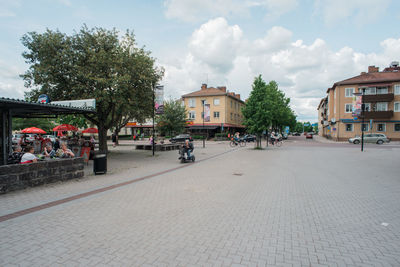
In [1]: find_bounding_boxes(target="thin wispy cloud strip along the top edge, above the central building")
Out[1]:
[164,0,298,22]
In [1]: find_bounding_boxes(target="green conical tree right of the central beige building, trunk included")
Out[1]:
[242,75,296,147]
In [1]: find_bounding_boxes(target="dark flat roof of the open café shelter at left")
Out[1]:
[0,97,96,118]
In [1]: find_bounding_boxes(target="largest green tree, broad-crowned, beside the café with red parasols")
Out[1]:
[21,26,163,154]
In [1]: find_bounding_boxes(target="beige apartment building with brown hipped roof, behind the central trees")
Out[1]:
[182,84,245,136]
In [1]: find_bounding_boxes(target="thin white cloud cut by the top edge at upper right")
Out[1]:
[315,0,391,26]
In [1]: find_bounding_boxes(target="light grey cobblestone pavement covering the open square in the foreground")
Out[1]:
[0,140,400,266]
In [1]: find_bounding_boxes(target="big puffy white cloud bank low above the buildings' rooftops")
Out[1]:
[161,18,400,121]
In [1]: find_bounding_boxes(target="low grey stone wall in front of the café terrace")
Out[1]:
[0,158,84,193]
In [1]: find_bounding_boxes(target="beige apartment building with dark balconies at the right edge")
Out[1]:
[318,62,400,141]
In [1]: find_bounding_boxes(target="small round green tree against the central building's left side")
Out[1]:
[156,100,187,135]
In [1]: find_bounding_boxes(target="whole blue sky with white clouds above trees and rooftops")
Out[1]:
[0,0,400,122]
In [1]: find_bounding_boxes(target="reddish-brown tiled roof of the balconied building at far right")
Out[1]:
[335,71,400,86]
